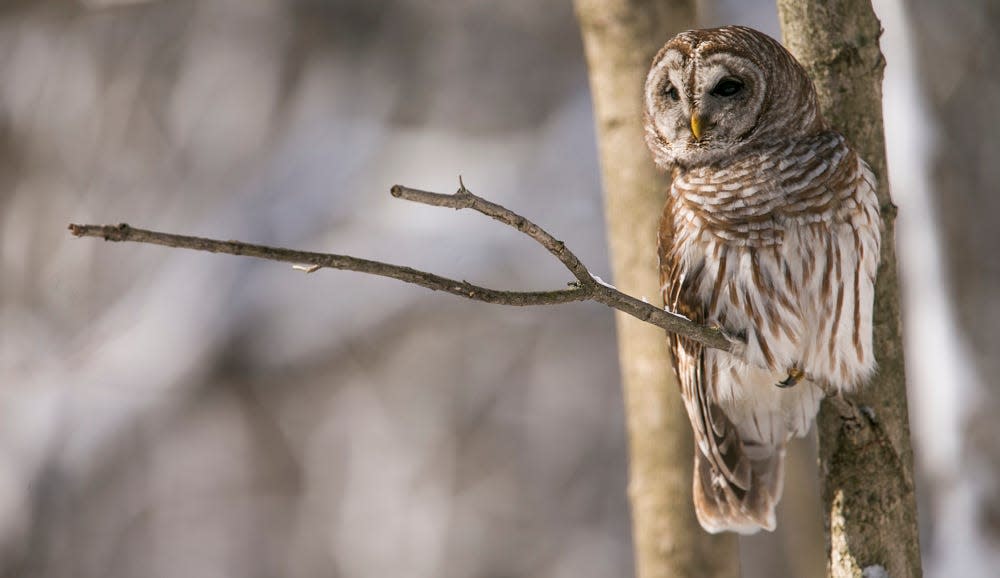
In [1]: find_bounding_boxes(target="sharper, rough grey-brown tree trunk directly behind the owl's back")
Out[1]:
[778,0,921,578]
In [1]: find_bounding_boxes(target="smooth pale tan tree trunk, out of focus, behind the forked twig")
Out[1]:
[575,0,739,578]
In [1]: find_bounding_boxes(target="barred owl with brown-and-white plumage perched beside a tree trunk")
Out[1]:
[645,26,880,534]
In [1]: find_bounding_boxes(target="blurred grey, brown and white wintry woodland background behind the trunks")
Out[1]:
[0,0,1000,577]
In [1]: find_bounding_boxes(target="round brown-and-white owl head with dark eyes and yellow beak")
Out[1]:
[645,26,823,168]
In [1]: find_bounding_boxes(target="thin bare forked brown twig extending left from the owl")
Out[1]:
[69,184,735,351]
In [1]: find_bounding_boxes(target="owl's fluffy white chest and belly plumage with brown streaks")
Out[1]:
[664,132,879,400]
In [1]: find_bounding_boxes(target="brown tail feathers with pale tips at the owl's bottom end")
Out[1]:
[694,434,785,534]
